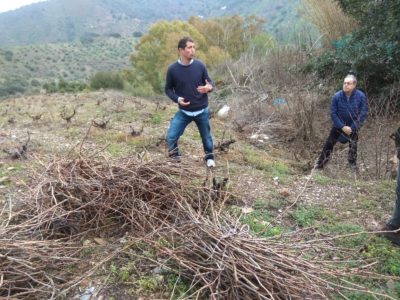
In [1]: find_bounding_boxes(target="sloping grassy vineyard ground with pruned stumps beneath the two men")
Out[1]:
[0,91,400,299]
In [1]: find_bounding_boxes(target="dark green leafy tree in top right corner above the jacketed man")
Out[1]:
[306,0,400,102]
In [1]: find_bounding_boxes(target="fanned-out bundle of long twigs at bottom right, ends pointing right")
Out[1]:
[138,218,390,300]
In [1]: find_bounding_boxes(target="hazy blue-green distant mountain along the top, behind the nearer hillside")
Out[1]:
[0,0,299,47]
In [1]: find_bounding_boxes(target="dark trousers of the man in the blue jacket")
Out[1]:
[317,127,358,167]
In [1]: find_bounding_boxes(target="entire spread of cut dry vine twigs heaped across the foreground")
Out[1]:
[0,156,396,299]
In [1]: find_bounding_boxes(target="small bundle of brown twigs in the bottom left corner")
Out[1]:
[0,239,79,299]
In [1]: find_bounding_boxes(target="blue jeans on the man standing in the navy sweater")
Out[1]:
[167,108,214,160]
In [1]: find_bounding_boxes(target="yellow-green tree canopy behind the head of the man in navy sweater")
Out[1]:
[131,16,265,92]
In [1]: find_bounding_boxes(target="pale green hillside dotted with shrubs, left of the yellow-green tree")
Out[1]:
[0,36,135,97]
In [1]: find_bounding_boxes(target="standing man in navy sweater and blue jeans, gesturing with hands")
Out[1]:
[165,37,215,167]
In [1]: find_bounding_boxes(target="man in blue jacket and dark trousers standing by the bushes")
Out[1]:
[315,75,368,170]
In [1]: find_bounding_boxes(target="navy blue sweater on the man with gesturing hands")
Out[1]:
[165,60,212,111]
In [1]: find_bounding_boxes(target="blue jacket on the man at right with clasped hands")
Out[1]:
[330,89,368,131]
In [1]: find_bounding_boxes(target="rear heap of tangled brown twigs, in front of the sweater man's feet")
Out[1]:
[12,157,210,238]
